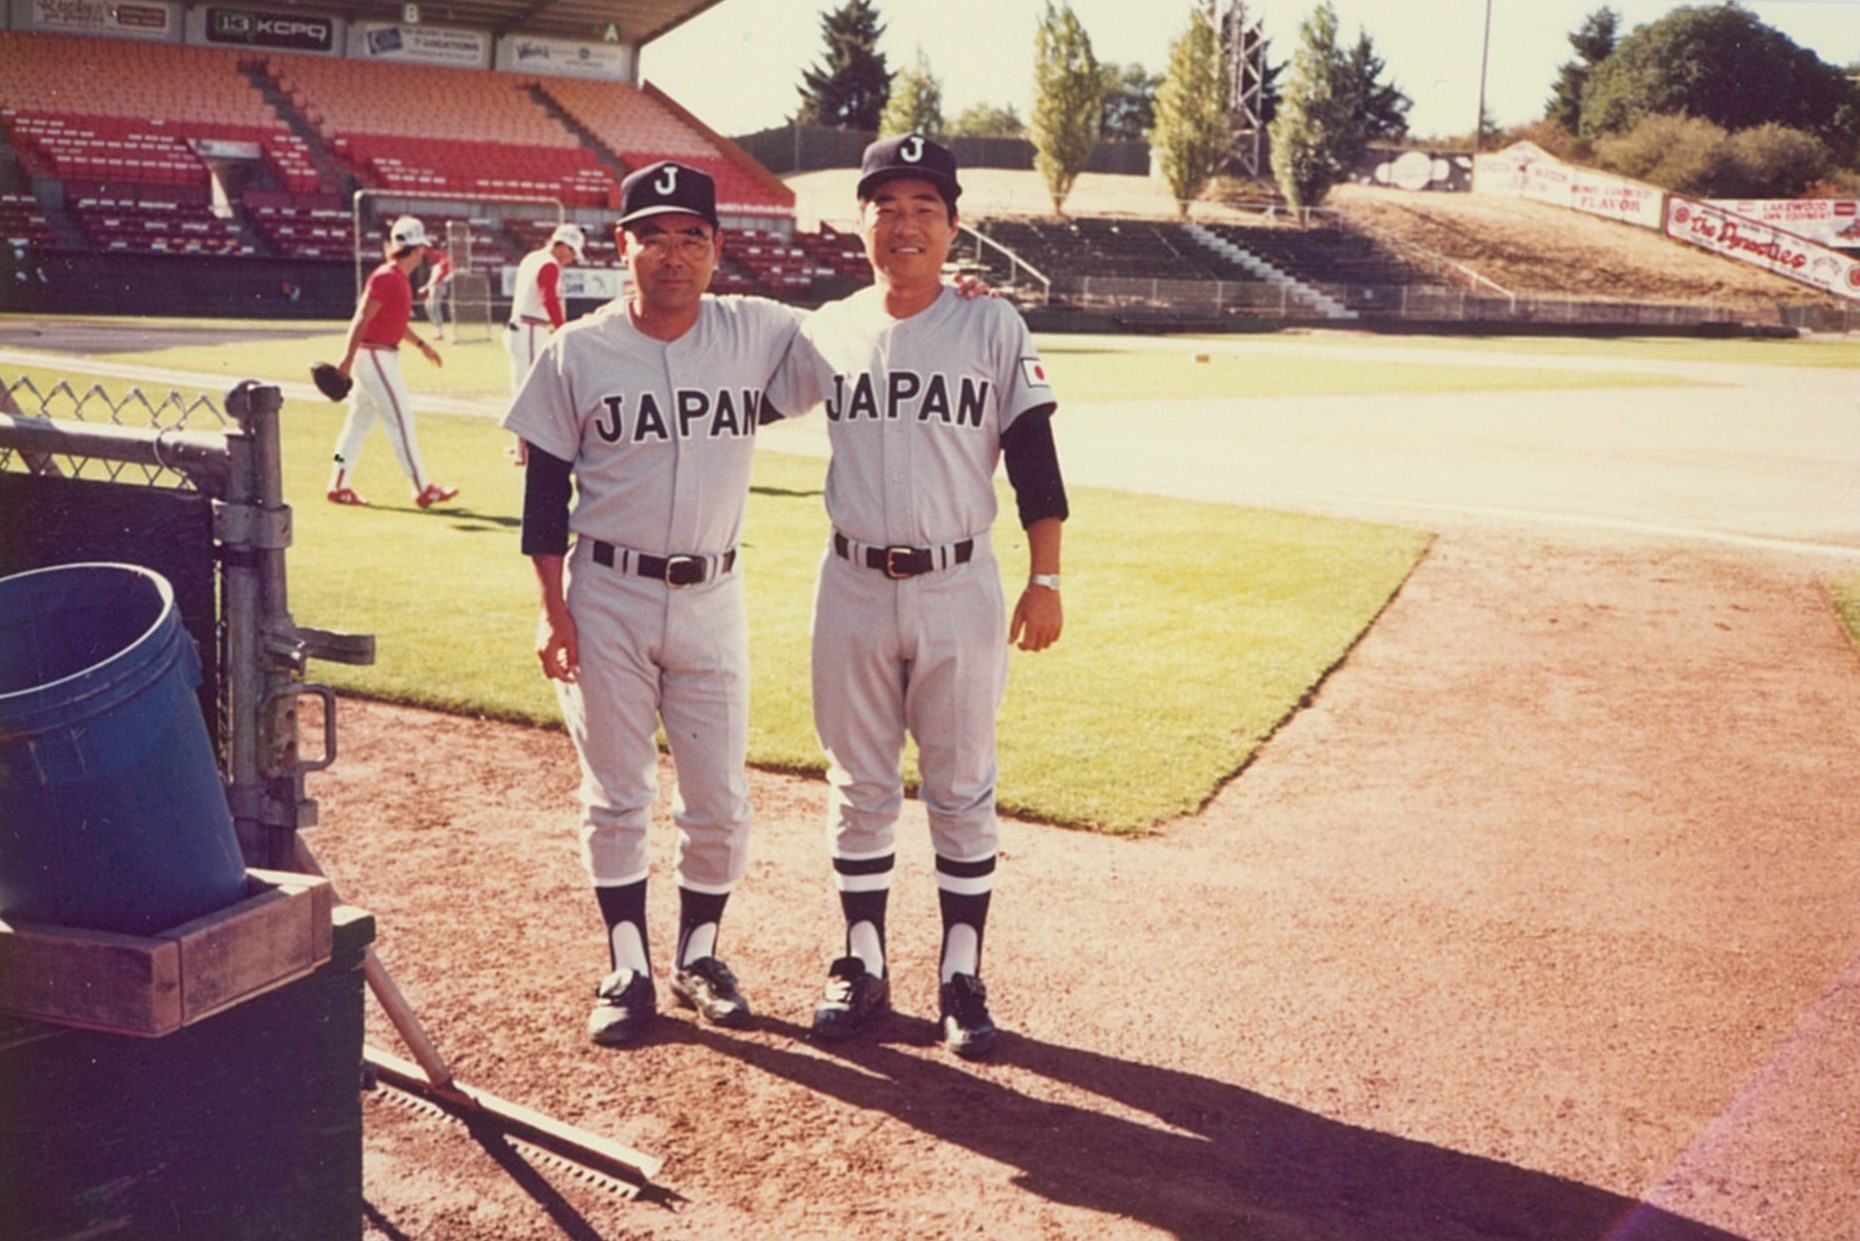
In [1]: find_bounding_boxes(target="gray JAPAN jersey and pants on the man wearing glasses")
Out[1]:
[504,296,796,893]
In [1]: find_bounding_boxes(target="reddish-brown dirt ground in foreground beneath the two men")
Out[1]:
[309,530,1860,1241]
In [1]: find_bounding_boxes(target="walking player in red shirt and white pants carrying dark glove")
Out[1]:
[327,216,459,508]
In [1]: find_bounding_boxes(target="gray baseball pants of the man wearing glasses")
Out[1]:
[556,540,751,893]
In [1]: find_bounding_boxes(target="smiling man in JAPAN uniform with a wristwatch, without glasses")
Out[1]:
[770,134,1068,1059]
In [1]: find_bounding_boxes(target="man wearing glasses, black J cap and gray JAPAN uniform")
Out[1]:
[504,162,798,1046]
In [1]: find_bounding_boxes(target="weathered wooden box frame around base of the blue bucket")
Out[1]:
[0,871,333,1038]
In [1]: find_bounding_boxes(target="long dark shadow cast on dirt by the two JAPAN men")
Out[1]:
[688,1018,1739,1241]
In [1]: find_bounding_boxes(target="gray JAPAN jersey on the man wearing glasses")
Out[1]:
[504,296,798,556]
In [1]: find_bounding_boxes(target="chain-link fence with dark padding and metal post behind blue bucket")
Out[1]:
[0,376,374,871]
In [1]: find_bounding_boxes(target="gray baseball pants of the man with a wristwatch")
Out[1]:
[813,536,1008,861]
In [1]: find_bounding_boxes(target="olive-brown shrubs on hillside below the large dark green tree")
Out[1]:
[1596,115,1834,199]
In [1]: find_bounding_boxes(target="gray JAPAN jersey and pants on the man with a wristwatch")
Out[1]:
[770,287,1055,870]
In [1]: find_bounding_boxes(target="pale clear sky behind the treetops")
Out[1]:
[642,0,1860,136]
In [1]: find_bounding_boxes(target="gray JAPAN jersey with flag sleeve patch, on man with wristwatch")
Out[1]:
[770,287,1055,547]
